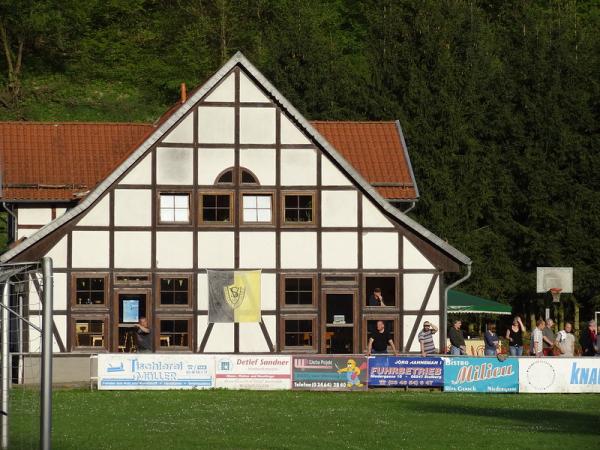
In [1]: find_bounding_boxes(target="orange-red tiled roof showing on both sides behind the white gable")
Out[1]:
[0,121,418,201]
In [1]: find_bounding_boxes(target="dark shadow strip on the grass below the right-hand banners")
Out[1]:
[403,401,600,435]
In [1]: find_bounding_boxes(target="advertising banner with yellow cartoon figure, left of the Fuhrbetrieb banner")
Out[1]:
[292,355,368,391]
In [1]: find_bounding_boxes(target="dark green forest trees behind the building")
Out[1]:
[0,0,600,317]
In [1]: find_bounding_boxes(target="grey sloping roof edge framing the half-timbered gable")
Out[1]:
[0,52,471,265]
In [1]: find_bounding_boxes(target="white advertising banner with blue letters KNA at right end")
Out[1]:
[519,357,600,393]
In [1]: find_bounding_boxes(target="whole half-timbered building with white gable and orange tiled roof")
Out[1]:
[0,53,471,353]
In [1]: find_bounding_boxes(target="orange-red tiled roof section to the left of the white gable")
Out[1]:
[0,122,154,201]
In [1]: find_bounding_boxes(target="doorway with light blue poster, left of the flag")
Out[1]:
[113,289,152,353]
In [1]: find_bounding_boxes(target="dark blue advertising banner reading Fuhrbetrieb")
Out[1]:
[369,356,444,387]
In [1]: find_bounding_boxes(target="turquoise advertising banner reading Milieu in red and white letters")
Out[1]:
[444,357,519,393]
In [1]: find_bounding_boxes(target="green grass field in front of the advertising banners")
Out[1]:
[10,389,600,450]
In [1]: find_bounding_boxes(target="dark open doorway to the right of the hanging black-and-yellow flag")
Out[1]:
[321,289,358,354]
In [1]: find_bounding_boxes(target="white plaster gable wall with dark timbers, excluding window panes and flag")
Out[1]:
[2,53,466,353]
